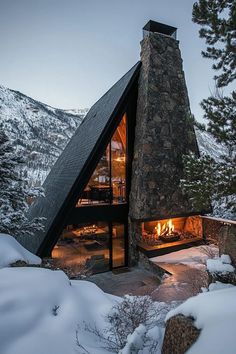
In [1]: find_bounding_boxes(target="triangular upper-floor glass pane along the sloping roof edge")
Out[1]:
[78,145,112,206]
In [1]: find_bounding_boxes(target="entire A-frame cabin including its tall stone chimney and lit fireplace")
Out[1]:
[22,21,208,272]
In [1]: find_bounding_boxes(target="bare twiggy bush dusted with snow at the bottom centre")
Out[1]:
[82,295,161,354]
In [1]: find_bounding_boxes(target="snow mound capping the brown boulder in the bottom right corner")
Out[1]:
[166,287,236,354]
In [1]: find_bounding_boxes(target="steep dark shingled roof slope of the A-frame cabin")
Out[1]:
[25,62,141,252]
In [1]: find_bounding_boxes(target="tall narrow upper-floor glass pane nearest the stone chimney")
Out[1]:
[111,114,127,204]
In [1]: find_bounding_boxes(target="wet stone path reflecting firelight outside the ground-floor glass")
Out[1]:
[88,263,205,302]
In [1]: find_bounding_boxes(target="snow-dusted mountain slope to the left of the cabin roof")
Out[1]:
[0,86,87,185]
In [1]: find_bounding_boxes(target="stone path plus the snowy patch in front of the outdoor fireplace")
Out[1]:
[88,245,218,302]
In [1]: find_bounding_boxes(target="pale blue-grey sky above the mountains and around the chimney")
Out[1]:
[0,0,217,119]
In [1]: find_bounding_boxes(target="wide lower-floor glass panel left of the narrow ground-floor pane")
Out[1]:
[52,222,110,273]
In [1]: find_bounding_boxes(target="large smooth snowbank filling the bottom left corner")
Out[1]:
[0,267,114,354]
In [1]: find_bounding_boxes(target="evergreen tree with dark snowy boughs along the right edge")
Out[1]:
[181,0,236,217]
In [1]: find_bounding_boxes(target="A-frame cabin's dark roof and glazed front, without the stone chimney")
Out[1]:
[28,63,141,271]
